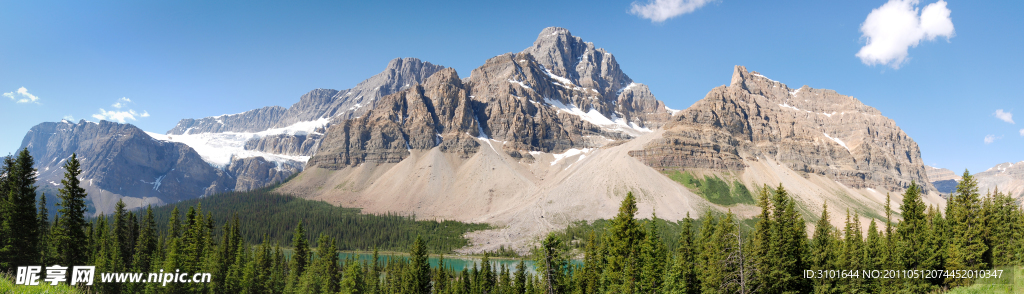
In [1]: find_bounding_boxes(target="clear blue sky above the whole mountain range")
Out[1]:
[0,0,1024,172]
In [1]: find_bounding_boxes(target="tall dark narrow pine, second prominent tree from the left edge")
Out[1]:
[51,154,89,265]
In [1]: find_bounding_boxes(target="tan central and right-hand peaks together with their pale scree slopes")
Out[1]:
[280,28,944,254]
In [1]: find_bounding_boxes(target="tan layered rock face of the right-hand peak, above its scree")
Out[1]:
[631,66,934,192]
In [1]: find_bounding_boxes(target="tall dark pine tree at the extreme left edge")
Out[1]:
[0,149,40,270]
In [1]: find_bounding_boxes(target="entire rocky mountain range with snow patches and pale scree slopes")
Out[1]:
[16,28,1024,251]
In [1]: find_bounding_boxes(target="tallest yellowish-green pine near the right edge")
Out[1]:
[946,171,988,287]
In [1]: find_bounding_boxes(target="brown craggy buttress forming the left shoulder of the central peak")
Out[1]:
[307,69,479,168]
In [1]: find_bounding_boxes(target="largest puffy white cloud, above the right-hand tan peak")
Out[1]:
[857,0,955,69]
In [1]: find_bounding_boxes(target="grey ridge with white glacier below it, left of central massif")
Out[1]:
[152,58,444,176]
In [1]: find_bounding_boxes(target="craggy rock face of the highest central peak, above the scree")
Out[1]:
[307,28,671,169]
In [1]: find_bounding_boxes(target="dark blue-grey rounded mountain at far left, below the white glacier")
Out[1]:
[22,121,298,212]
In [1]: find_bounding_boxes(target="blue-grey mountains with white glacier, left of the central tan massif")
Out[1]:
[22,58,443,212]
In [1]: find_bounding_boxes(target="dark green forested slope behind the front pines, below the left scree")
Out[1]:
[153,187,489,252]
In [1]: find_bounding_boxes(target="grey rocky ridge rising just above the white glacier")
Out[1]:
[167,58,444,135]
